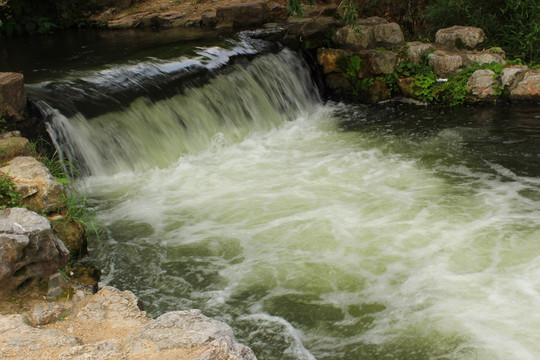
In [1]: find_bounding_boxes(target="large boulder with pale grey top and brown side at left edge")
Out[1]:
[0,208,69,293]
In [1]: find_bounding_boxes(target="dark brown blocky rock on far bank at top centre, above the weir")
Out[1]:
[216,2,268,28]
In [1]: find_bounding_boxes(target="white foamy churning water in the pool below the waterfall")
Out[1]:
[82,103,540,359]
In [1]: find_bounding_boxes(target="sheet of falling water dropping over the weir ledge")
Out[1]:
[43,50,318,174]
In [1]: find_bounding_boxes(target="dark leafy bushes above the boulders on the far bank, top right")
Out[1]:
[288,0,540,64]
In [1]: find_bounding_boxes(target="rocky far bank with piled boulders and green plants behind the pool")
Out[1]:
[93,1,540,105]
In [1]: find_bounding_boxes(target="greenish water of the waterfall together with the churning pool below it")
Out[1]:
[4,28,540,360]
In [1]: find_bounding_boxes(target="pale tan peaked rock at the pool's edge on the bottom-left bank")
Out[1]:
[77,286,149,326]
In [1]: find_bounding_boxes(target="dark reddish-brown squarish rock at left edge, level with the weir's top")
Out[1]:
[0,72,26,120]
